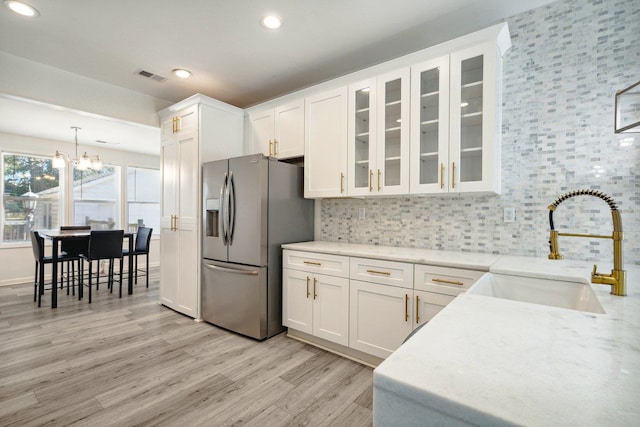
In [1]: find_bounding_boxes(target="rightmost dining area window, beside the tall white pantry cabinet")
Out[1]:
[127,167,161,235]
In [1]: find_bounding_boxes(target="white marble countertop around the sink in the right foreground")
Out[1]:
[374,256,640,426]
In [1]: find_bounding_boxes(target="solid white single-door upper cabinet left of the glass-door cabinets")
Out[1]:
[304,87,347,198]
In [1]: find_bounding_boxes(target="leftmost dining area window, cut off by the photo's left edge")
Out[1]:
[2,153,62,243]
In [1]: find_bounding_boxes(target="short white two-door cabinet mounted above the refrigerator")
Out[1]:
[248,99,304,159]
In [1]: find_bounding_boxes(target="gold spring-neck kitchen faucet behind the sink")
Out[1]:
[549,190,627,296]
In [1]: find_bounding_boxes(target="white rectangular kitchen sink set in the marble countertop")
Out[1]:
[467,273,605,313]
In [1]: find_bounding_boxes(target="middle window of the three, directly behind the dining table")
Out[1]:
[73,165,120,230]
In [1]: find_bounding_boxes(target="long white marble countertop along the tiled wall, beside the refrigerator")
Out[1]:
[282,241,500,271]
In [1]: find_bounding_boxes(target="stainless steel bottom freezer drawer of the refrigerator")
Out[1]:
[202,260,267,339]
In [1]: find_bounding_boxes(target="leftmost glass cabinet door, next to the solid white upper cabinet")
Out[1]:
[347,79,376,196]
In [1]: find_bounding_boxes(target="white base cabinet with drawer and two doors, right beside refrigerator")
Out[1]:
[282,251,349,346]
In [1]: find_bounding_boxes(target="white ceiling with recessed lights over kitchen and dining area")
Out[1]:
[0,0,553,152]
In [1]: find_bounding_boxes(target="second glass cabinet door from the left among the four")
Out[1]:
[374,68,410,194]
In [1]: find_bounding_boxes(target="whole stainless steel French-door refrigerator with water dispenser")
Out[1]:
[201,154,314,340]
